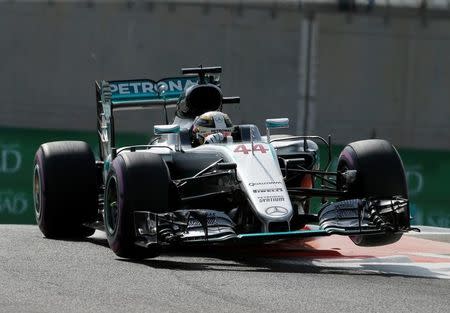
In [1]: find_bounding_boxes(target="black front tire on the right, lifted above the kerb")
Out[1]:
[337,139,410,247]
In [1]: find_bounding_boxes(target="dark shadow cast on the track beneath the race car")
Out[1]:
[86,229,442,279]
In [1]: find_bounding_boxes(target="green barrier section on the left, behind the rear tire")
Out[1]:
[0,128,149,224]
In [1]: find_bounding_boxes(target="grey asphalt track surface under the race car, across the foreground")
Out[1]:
[0,225,450,313]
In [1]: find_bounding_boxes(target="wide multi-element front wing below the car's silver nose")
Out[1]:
[134,197,410,247]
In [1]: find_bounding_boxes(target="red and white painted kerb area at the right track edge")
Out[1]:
[268,226,450,280]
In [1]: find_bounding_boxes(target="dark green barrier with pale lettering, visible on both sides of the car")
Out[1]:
[0,128,450,227]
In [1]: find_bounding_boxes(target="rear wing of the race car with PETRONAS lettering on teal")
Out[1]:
[95,66,240,160]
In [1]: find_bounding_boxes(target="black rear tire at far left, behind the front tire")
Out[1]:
[33,141,98,239]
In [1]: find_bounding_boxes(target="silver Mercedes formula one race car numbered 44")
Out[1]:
[34,67,411,258]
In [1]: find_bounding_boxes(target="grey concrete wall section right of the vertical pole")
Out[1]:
[314,15,450,149]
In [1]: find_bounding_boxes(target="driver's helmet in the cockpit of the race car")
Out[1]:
[192,111,233,146]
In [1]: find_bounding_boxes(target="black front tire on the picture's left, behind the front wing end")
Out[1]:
[104,152,172,259]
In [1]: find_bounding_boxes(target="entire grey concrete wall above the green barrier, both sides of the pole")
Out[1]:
[0,1,450,149]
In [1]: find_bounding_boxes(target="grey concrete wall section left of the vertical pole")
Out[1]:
[0,1,301,132]
